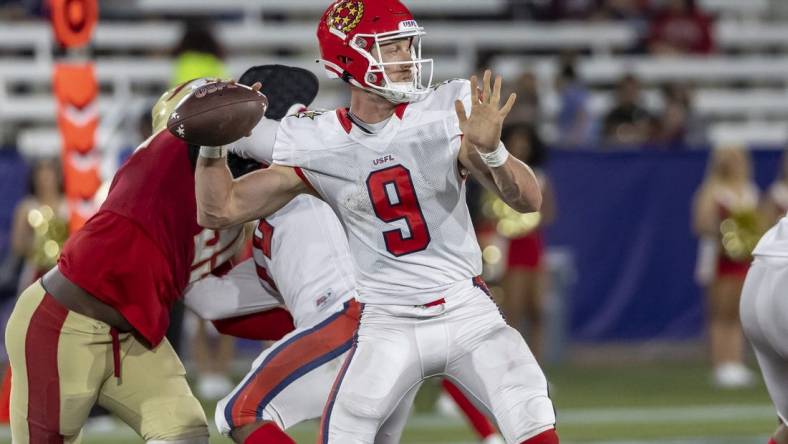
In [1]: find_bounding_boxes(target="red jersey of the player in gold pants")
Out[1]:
[58,131,243,346]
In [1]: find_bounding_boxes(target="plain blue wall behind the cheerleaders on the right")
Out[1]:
[548,150,780,342]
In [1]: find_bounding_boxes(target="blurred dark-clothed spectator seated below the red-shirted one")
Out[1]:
[655,83,706,149]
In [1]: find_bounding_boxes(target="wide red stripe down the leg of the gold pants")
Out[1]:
[25,294,68,444]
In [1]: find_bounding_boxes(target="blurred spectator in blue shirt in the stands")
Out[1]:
[555,59,594,148]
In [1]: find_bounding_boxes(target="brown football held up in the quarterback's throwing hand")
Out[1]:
[167,81,268,146]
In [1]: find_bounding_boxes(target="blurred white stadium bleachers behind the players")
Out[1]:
[0,0,788,158]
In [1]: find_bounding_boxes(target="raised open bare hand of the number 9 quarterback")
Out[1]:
[454,69,517,152]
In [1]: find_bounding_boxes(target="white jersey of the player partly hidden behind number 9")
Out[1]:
[252,194,356,327]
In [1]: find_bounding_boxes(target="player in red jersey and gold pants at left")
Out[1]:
[5,80,290,444]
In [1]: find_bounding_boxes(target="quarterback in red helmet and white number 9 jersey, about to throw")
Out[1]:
[197,0,558,444]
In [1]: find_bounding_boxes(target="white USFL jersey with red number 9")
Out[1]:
[274,80,481,305]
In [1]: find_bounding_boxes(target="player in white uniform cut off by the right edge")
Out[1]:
[739,212,788,444]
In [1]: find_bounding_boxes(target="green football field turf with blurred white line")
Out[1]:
[0,363,776,444]
